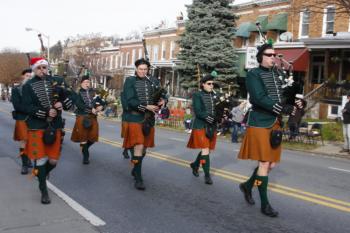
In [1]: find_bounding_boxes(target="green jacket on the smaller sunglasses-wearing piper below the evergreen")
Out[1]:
[192,90,216,129]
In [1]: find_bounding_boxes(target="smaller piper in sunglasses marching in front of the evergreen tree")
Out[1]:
[187,74,218,185]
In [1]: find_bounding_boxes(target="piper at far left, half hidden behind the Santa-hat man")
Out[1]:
[11,69,32,175]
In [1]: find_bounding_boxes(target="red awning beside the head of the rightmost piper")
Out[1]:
[275,48,310,72]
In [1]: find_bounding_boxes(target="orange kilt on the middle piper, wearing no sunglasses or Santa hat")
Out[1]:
[123,122,154,148]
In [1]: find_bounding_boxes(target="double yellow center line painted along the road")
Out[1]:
[0,109,350,213]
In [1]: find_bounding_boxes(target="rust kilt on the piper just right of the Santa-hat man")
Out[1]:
[71,114,98,142]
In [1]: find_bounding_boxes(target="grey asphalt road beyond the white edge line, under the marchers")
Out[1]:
[0,103,350,233]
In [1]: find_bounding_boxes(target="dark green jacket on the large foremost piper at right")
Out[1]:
[246,67,281,128]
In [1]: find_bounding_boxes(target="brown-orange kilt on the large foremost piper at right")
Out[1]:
[238,123,282,162]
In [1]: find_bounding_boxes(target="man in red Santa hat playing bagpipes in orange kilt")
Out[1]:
[22,57,72,204]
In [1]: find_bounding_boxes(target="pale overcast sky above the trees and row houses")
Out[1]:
[0,0,247,52]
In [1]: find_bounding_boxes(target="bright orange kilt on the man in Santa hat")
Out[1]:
[26,129,62,160]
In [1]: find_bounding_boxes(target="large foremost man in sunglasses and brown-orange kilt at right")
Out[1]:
[238,43,303,217]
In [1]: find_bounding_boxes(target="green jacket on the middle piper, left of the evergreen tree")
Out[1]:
[123,76,159,125]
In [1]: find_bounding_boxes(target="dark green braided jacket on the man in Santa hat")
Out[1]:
[22,76,72,130]
